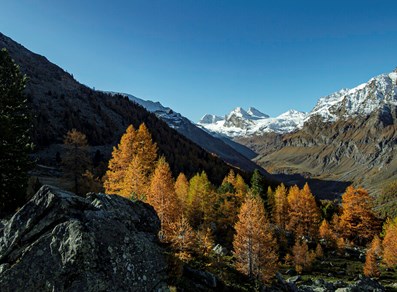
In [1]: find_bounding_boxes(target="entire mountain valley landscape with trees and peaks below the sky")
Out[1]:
[0,28,397,291]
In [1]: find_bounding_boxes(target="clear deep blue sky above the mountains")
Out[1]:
[0,0,397,121]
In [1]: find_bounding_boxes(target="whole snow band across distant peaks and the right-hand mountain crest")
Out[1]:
[198,71,397,137]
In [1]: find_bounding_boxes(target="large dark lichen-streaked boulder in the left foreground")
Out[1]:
[0,186,167,291]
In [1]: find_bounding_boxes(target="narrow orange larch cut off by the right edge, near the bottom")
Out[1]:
[382,217,397,268]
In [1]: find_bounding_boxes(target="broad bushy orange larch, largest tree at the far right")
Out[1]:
[340,186,380,244]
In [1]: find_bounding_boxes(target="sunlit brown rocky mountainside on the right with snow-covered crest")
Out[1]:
[236,72,397,193]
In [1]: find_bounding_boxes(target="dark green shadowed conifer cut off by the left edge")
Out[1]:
[0,49,33,217]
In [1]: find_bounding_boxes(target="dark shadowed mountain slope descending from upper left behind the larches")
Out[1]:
[0,33,268,183]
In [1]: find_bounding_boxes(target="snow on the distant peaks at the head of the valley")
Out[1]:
[198,107,307,137]
